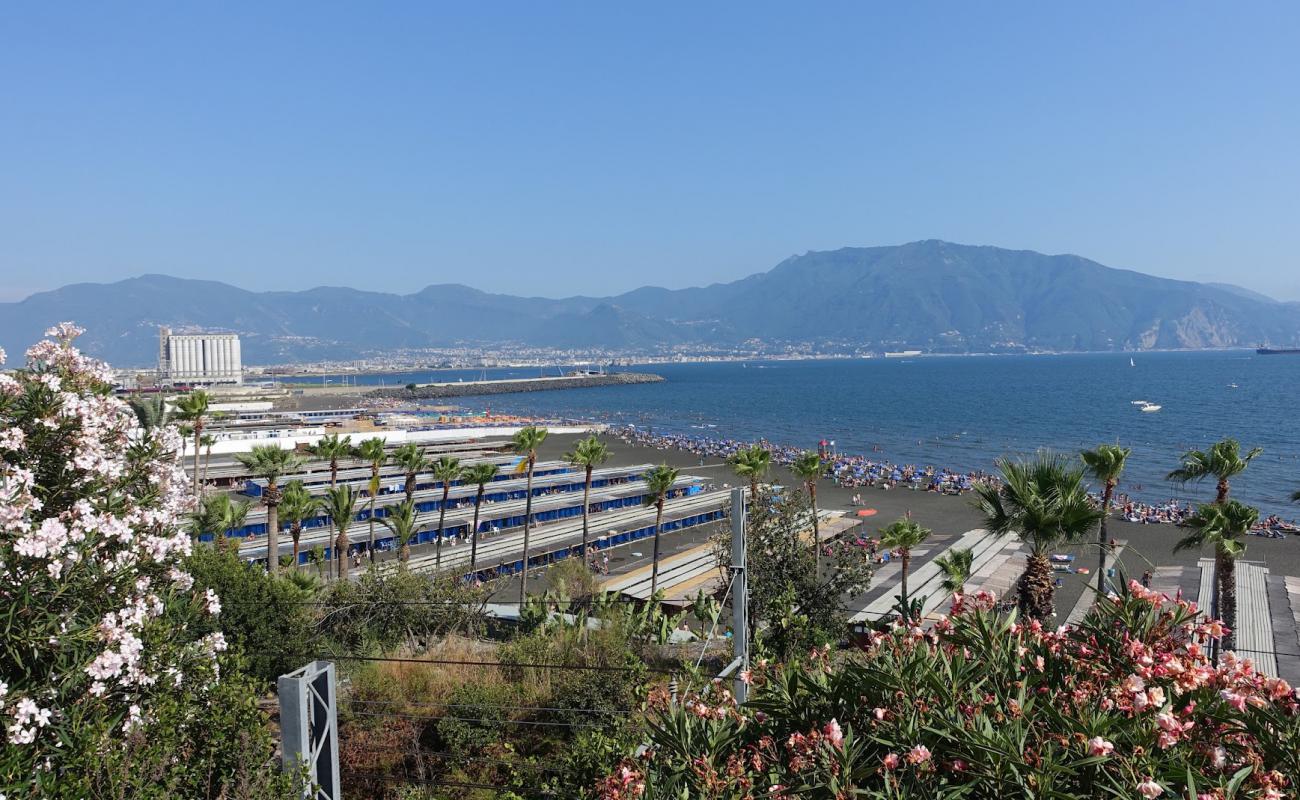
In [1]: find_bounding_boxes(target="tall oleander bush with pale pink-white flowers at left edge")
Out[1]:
[0,324,286,800]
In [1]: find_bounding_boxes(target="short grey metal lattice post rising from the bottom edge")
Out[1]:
[276,661,343,800]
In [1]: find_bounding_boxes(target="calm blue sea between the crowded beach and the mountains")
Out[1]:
[332,351,1300,518]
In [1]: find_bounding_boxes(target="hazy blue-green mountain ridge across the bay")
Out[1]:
[0,239,1300,366]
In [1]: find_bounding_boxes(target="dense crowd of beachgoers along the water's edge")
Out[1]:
[610,425,1300,537]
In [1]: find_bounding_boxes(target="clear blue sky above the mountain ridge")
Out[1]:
[0,1,1300,299]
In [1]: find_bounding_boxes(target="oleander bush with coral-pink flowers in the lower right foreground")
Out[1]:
[598,583,1300,800]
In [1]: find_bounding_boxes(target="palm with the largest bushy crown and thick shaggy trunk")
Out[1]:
[975,453,1101,619]
